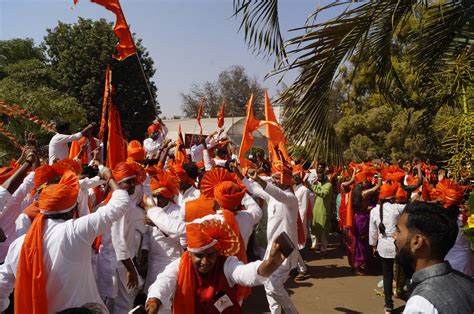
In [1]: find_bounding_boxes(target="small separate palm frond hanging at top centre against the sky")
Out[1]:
[234,0,287,62]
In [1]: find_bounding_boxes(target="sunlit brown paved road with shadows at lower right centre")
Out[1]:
[243,236,404,314]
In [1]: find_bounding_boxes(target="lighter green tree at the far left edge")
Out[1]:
[0,39,86,163]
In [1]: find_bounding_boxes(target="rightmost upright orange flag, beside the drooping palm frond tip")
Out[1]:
[265,91,290,162]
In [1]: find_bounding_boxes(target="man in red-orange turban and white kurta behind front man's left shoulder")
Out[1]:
[142,172,186,291]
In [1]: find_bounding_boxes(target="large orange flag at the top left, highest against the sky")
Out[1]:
[74,0,137,61]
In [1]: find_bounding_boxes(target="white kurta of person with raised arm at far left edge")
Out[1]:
[0,171,35,262]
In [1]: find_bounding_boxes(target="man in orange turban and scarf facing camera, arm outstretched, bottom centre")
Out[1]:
[146,215,284,314]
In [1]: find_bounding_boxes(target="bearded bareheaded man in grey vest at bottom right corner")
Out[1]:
[394,202,474,314]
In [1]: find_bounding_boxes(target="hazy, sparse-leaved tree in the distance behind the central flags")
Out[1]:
[181,65,264,118]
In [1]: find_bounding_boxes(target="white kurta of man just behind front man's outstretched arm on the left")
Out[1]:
[143,202,186,291]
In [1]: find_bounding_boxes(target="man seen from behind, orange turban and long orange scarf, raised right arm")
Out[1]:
[0,168,129,313]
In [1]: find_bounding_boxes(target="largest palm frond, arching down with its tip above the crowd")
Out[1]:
[273,0,422,161]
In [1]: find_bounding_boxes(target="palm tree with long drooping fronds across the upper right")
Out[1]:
[234,0,474,162]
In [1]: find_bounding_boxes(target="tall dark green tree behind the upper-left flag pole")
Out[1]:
[42,18,159,138]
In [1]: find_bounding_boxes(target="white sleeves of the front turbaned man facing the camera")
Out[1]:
[148,256,267,309]
